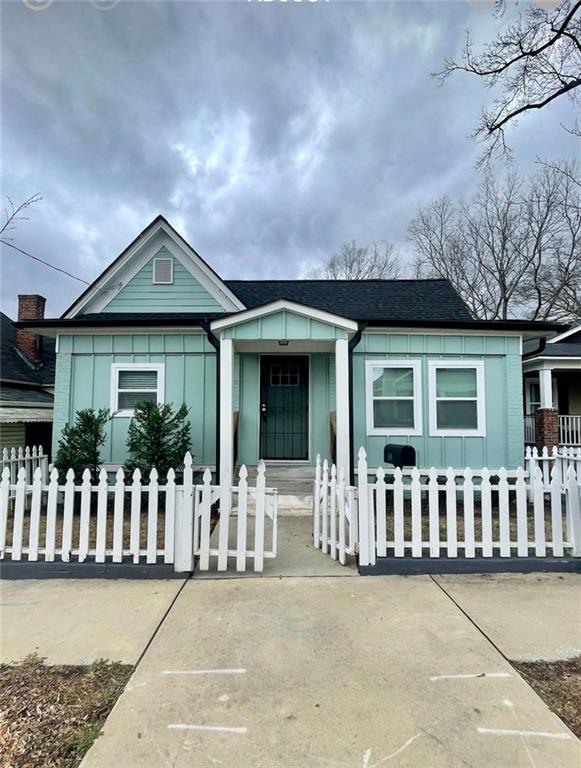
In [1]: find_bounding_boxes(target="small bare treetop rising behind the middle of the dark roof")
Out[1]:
[307,240,400,280]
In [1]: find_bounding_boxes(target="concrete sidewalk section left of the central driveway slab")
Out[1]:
[0,579,183,664]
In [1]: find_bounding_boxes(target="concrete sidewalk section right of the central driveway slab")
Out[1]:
[434,573,581,661]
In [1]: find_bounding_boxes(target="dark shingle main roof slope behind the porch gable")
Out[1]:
[225,280,472,322]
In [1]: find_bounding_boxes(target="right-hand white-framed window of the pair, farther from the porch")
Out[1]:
[428,360,486,437]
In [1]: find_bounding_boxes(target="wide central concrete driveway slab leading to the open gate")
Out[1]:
[83,576,581,768]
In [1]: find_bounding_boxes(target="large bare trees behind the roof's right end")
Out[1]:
[409,164,581,320]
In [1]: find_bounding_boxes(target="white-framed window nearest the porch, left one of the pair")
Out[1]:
[365,360,422,435]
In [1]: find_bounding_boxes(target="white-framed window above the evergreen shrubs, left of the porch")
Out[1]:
[111,363,165,417]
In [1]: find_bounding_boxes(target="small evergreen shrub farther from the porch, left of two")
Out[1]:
[54,408,111,482]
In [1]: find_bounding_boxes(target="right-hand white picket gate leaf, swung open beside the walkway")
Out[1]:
[313,455,358,565]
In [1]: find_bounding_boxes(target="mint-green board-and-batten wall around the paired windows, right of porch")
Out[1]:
[353,332,524,469]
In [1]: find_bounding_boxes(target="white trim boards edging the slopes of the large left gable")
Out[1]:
[64,221,245,320]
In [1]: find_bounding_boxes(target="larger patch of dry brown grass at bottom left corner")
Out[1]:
[0,656,133,768]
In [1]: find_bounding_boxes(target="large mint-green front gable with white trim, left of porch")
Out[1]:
[63,216,245,320]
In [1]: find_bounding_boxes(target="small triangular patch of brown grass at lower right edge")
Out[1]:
[511,656,581,738]
